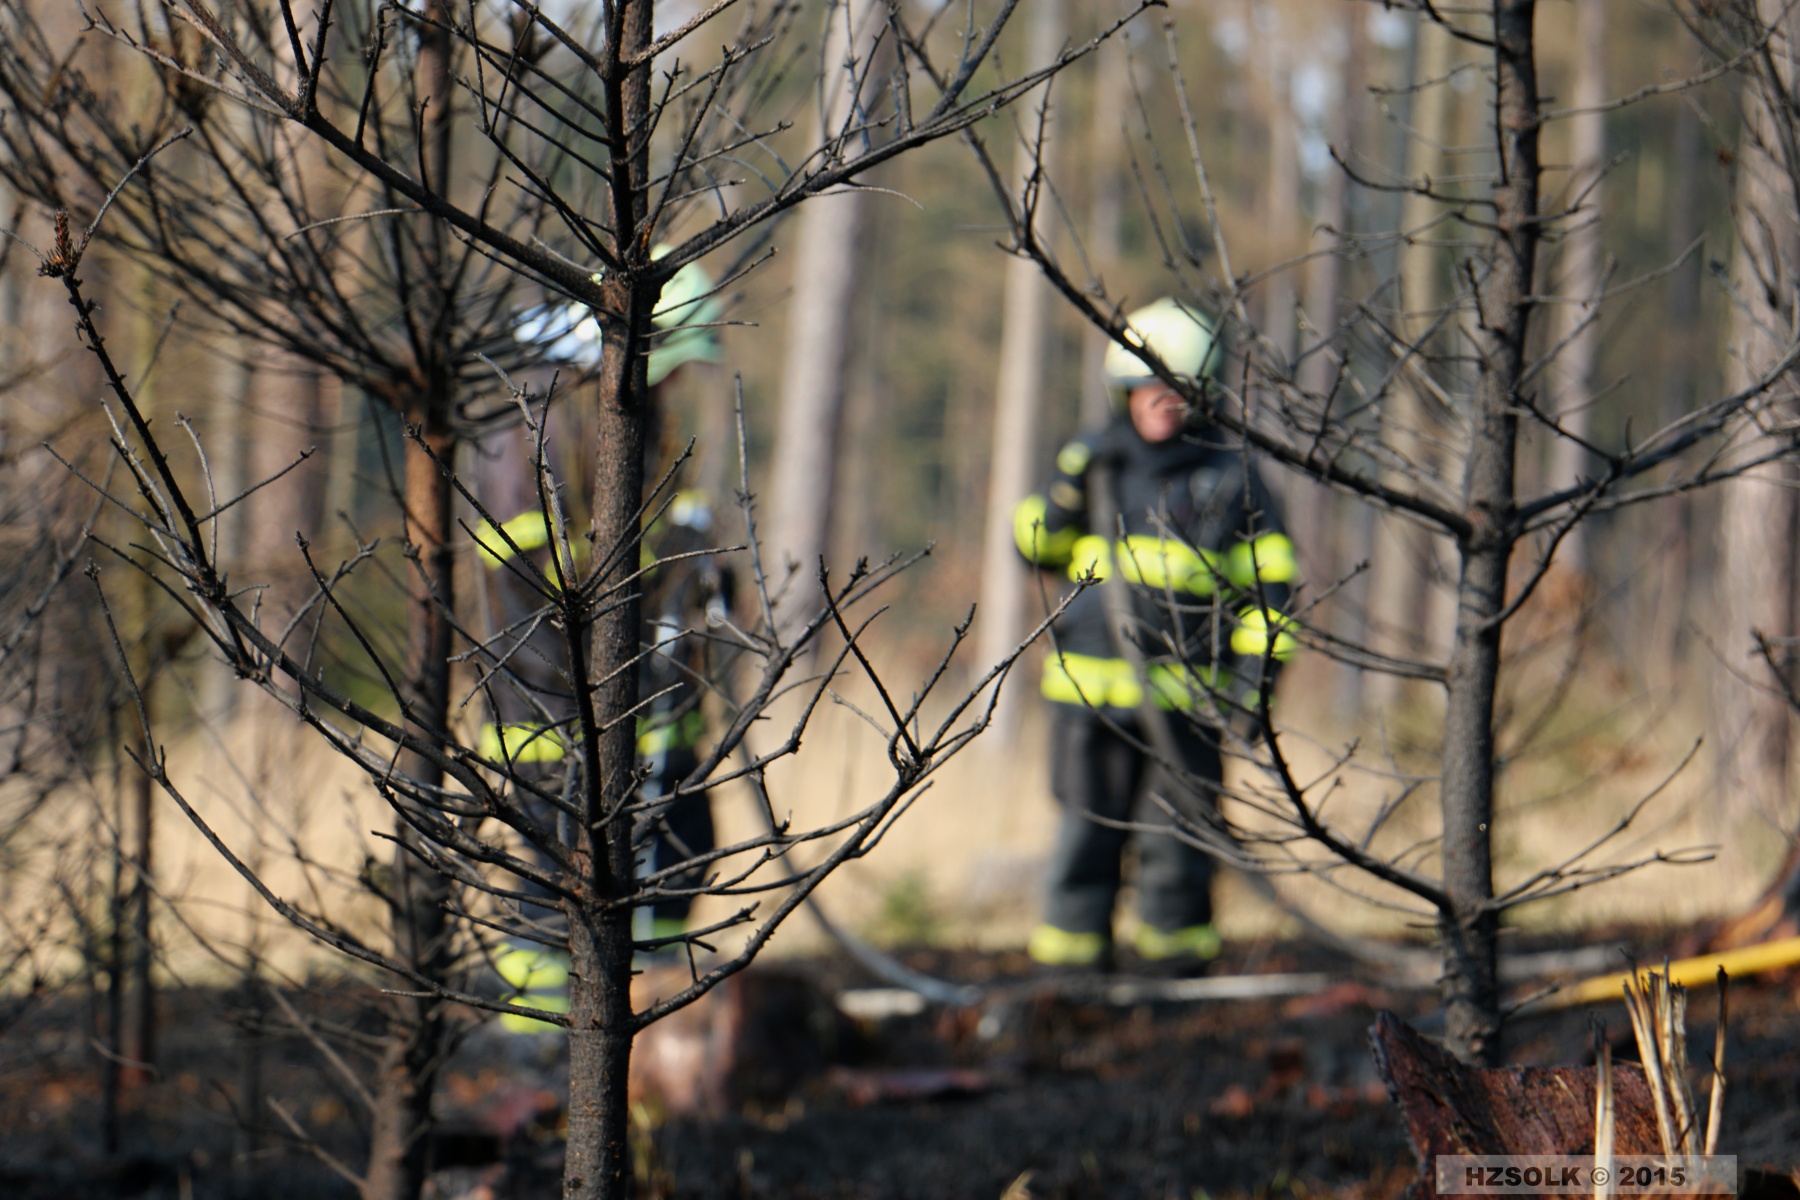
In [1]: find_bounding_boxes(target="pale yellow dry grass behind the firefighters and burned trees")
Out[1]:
[4,633,1782,979]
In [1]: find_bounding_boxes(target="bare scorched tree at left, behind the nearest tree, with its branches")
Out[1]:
[0,4,604,1200]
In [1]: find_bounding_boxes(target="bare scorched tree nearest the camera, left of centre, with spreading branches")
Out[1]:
[14,0,1116,1196]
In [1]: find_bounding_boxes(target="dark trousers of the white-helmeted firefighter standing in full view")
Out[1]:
[1044,703,1224,937]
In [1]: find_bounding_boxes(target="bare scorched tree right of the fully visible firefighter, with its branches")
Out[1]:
[990,0,1796,1061]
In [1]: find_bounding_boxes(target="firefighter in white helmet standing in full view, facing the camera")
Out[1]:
[1013,299,1298,970]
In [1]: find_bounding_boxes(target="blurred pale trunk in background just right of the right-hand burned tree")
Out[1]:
[1550,4,1607,576]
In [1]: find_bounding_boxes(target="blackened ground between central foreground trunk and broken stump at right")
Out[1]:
[657,954,1413,1200]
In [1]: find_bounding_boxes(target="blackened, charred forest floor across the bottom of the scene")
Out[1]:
[0,936,1800,1200]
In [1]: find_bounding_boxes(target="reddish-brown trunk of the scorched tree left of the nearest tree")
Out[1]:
[362,0,455,1200]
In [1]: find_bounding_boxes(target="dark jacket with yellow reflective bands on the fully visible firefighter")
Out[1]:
[1013,417,1298,709]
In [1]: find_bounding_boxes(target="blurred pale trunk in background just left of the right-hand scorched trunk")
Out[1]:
[1366,22,1454,711]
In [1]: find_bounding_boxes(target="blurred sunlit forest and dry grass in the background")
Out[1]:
[0,0,1796,1065]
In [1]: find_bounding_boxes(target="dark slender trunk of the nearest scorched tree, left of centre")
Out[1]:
[563,0,659,1200]
